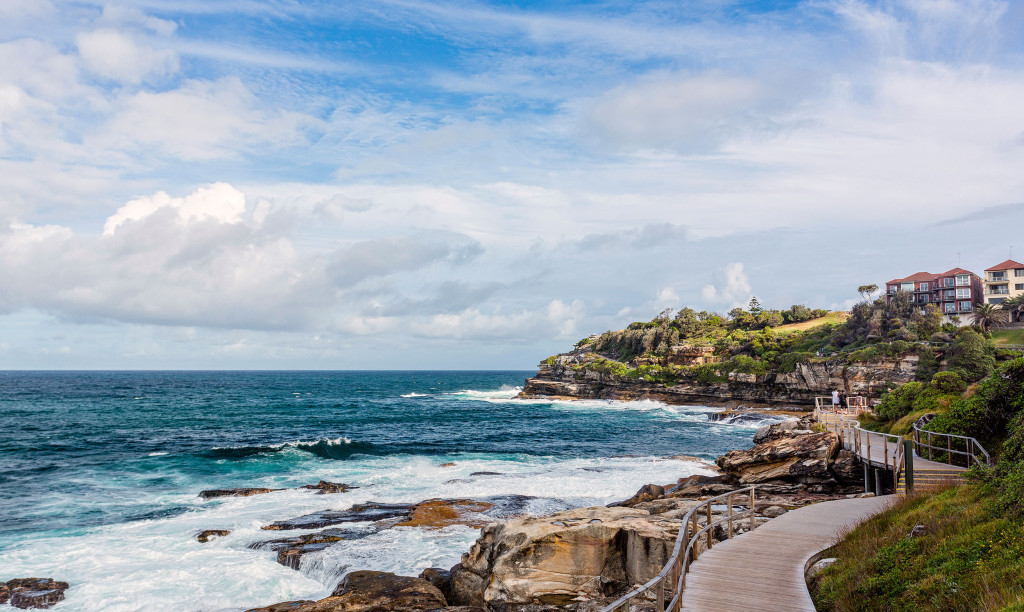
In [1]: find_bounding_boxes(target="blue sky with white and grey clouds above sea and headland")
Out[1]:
[0,0,1024,369]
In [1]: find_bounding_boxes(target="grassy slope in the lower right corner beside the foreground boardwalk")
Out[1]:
[812,484,1024,612]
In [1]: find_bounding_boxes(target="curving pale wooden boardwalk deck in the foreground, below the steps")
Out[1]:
[683,495,893,612]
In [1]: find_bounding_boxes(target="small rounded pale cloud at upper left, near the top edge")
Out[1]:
[75,28,178,84]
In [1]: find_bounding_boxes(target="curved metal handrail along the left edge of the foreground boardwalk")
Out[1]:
[599,486,757,612]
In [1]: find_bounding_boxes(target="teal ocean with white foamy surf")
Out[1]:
[0,371,760,611]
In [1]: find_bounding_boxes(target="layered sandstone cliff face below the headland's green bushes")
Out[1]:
[519,352,918,409]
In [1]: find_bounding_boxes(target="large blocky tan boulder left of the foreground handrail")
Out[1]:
[452,507,680,606]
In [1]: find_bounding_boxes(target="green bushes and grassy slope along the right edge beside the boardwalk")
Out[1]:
[813,358,1024,611]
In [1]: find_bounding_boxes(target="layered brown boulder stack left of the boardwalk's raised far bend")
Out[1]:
[716,432,840,485]
